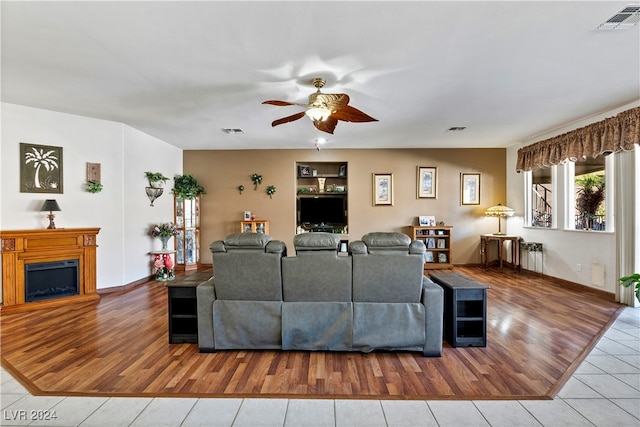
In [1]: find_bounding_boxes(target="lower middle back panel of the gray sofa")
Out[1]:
[282,302,353,351]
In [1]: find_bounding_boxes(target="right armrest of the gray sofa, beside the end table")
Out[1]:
[422,276,444,357]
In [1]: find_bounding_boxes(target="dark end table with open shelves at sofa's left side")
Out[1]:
[165,271,213,344]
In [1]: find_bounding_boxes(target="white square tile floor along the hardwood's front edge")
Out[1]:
[0,308,640,427]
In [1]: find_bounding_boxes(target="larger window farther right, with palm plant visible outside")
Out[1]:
[567,156,613,231]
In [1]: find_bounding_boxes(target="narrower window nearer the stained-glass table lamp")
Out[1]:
[525,166,556,228]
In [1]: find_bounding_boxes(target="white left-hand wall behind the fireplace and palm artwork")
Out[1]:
[0,103,182,289]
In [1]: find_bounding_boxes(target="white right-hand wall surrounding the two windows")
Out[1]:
[507,103,638,293]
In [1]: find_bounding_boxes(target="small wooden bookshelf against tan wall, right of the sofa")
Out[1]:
[409,225,453,270]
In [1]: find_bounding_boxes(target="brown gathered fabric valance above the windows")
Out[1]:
[516,107,640,172]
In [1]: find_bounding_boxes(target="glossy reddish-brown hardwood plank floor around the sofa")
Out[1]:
[0,267,623,400]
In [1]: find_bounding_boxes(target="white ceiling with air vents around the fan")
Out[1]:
[1,0,640,149]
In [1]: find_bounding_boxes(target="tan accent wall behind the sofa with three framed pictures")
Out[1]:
[184,149,506,264]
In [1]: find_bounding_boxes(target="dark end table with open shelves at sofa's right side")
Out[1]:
[430,273,489,347]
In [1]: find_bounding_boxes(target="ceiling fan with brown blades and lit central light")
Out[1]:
[263,78,378,134]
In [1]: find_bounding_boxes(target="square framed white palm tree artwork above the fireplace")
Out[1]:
[20,142,63,194]
